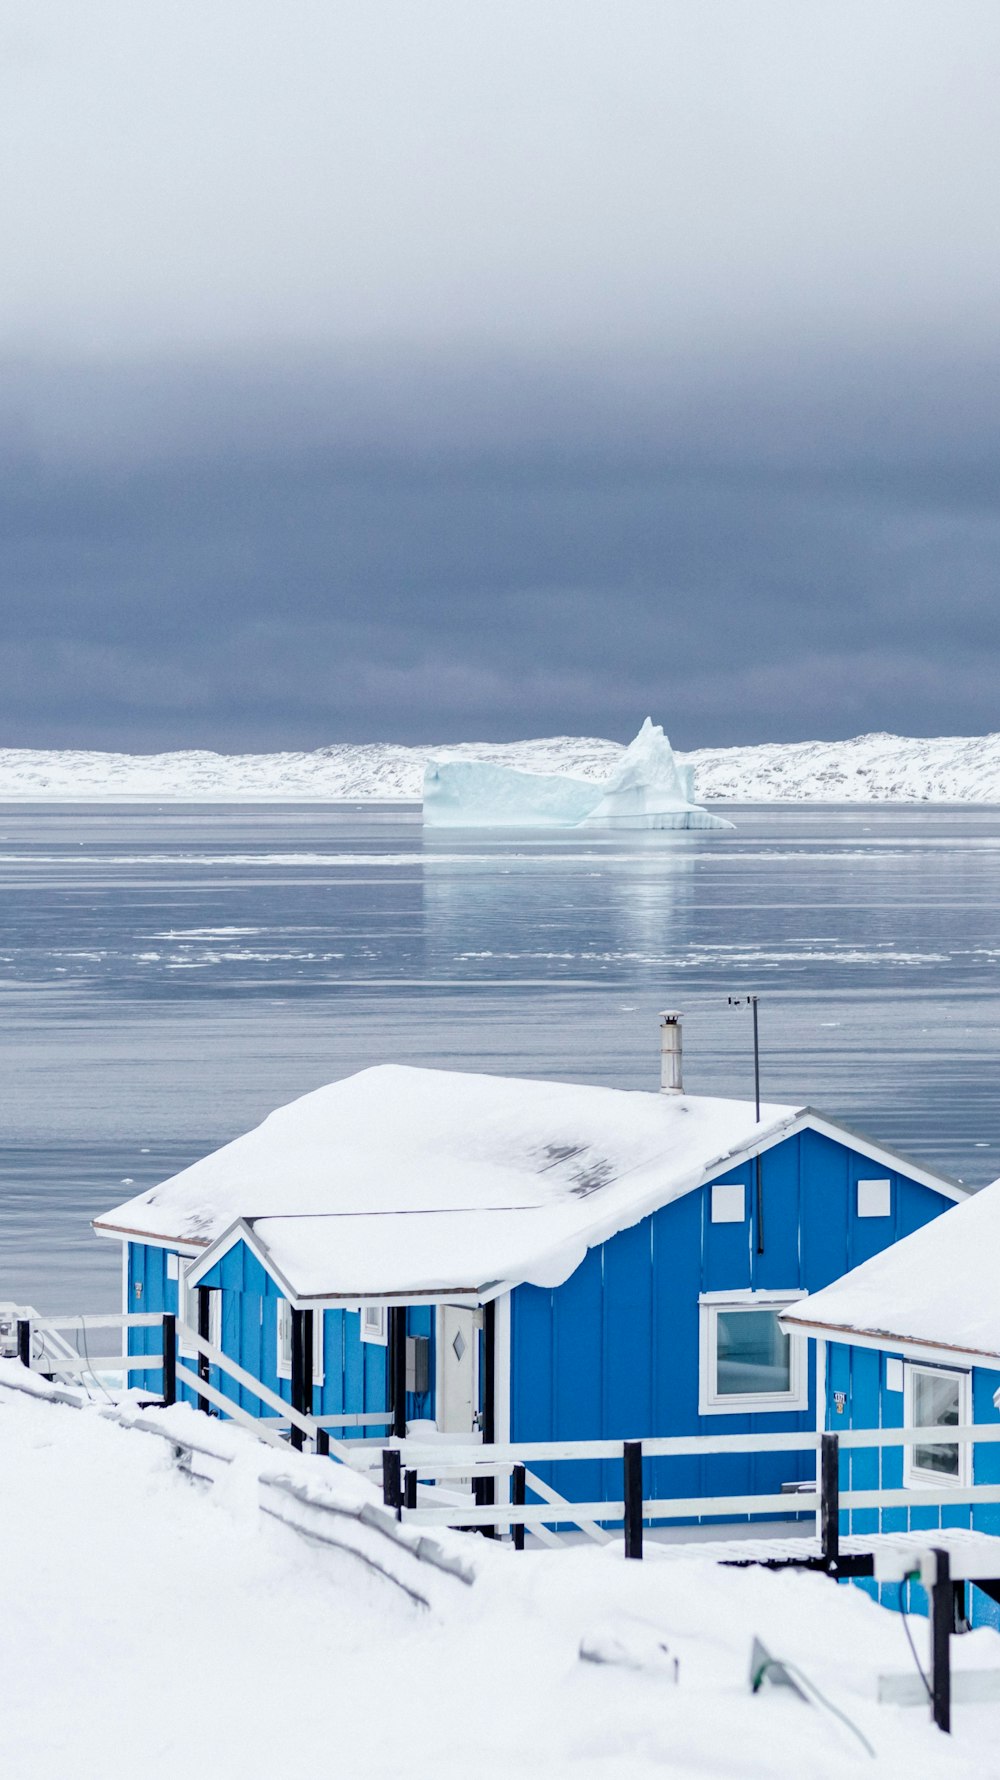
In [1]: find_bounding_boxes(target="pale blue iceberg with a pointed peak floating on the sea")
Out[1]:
[423,717,733,829]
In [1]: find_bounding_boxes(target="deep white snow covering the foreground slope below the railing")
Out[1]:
[0,1387,1000,1780]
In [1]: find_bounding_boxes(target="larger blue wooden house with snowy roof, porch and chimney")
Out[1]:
[94,1015,964,1501]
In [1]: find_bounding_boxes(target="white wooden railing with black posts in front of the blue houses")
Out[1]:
[18,1312,1000,1575]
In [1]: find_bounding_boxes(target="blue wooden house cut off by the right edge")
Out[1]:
[783,1182,1000,1625]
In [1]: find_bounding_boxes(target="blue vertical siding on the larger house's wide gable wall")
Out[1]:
[511,1130,952,1523]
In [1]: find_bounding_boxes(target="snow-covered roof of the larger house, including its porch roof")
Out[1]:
[94,1064,799,1296]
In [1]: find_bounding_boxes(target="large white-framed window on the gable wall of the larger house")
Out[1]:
[698,1292,810,1415]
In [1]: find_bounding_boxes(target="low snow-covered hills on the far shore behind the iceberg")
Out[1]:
[0,735,1000,803]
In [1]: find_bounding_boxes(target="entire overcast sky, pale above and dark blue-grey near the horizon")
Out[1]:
[0,0,1000,749]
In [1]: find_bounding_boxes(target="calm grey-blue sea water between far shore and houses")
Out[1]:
[0,805,1000,1312]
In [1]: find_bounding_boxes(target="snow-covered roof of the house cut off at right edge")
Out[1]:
[781,1180,1000,1362]
